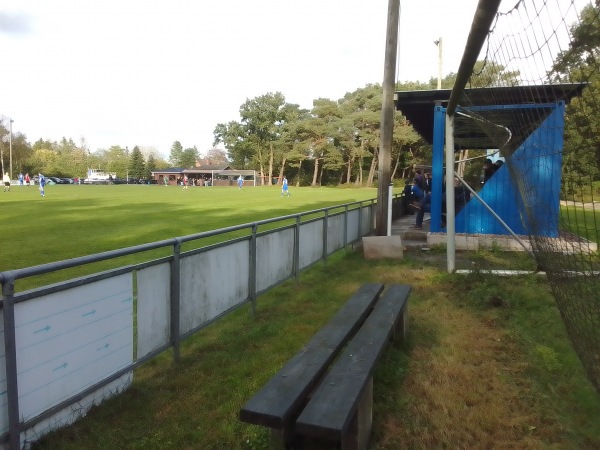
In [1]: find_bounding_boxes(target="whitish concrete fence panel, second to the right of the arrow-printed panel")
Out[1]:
[179,241,250,333]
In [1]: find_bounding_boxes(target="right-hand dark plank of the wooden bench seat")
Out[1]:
[295,285,411,441]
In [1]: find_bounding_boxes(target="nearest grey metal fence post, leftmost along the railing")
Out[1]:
[2,278,21,449]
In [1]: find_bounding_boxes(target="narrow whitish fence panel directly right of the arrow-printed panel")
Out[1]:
[137,263,171,359]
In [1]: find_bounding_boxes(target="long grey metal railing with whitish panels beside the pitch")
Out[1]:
[0,195,402,448]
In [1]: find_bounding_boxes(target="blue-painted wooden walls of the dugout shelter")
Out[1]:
[430,102,564,237]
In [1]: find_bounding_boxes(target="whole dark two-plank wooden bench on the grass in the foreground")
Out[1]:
[240,283,411,449]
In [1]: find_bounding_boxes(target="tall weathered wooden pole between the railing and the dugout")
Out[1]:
[376,0,400,236]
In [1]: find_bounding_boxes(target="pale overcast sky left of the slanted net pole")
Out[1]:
[0,0,478,158]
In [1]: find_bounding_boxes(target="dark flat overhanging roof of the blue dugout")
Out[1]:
[395,83,587,149]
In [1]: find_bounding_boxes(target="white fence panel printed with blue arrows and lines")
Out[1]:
[15,273,133,420]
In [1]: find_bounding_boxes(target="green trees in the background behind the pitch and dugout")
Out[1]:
[0,0,600,189]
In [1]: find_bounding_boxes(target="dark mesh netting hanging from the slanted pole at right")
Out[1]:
[454,0,600,390]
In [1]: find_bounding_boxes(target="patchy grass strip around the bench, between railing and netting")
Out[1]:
[33,251,600,450]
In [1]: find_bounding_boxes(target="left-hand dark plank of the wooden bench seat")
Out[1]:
[240,283,384,429]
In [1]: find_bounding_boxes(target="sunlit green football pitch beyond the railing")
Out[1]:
[0,185,377,271]
